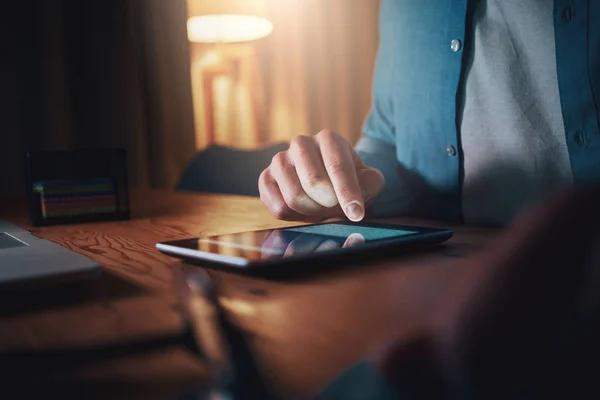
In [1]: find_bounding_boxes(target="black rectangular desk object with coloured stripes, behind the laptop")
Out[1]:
[26,149,130,226]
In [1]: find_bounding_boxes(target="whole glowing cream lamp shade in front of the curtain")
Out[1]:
[187,0,273,43]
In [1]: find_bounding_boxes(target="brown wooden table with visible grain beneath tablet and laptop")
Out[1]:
[0,190,497,398]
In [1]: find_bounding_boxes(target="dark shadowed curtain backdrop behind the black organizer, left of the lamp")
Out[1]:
[0,0,195,196]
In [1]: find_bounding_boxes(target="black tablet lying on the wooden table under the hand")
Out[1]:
[156,222,453,274]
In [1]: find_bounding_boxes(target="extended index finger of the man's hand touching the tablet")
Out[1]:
[317,132,365,222]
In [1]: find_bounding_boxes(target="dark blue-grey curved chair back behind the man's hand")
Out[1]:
[177,143,288,196]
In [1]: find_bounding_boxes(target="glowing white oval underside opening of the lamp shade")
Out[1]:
[187,14,273,43]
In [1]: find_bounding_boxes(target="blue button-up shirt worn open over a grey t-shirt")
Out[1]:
[357,0,600,222]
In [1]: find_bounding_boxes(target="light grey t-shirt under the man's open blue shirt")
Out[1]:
[460,0,573,224]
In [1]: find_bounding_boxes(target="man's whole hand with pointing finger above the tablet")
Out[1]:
[258,130,384,221]
